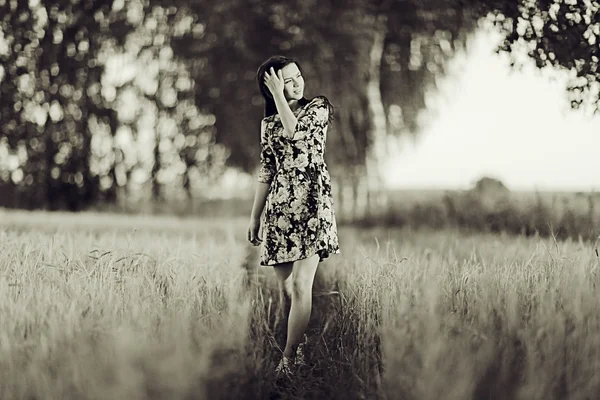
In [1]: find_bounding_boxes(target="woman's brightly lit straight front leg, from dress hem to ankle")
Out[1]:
[283,254,319,358]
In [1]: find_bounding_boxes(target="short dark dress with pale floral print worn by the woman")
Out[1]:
[258,97,340,266]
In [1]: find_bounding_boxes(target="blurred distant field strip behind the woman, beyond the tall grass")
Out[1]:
[176,190,600,242]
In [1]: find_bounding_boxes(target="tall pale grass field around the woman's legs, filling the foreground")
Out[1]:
[0,210,600,400]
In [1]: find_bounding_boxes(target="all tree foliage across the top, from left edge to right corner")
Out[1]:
[0,0,600,209]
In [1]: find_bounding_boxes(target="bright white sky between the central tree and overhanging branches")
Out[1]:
[384,23,600,191]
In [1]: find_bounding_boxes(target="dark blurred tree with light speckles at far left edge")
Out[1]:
[0,0,132,210]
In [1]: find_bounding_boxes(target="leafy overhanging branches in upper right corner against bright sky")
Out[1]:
[481,0,600,113]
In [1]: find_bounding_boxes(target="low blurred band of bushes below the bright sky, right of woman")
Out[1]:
[356,189,600,241]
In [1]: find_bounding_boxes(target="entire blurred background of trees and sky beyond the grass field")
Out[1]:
[0,0,600,238]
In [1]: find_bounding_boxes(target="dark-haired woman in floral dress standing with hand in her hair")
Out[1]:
[247,56,340,375]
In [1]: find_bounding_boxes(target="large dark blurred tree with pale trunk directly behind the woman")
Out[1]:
[155,0,492,219]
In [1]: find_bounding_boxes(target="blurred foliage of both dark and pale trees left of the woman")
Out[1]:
[0,0,227,210]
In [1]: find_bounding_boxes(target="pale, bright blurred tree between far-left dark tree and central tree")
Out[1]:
[103,0,227,206]
